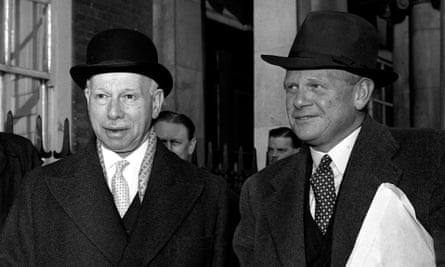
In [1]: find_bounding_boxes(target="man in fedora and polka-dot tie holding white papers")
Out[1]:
[234,11,445,266]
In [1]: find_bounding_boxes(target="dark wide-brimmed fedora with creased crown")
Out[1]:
[261,11,397,87]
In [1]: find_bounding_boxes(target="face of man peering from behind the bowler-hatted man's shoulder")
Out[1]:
[154,121,196,161]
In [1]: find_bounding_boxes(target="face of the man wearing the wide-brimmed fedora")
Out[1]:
[284,70,364,152]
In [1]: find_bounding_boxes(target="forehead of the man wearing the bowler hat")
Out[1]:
[89,72,155,88]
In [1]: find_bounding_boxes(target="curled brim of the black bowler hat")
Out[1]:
[70,62,173,96]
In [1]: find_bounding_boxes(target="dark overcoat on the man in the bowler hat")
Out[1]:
[0,139,237,266]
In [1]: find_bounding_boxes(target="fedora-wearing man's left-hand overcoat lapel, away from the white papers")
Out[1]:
[263,147,310,266]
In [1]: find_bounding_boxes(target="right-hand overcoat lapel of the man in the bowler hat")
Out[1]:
[120,146,204,266]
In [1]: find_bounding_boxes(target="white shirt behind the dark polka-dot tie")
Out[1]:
[309,127,361,218]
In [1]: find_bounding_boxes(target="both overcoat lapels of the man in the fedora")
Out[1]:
[263,117,401,266]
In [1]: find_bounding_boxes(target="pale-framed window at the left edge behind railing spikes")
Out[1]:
[0,0,53,141]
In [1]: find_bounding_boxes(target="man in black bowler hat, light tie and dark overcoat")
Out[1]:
[0,29,237,266]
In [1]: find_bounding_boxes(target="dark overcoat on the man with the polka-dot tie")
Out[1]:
[234,117,445,267]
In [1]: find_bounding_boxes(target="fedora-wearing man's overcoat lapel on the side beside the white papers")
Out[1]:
[332,118,401,266]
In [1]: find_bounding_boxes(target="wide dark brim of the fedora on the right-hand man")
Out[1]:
[261,55,398,87]
